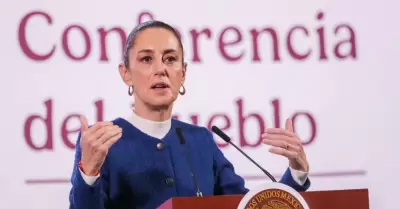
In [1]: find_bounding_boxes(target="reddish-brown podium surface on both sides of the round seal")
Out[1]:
[158,189,369,209]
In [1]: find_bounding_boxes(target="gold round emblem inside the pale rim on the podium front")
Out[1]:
[245,189,304,209]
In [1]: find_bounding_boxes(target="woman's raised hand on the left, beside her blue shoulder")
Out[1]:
[80,116,122,176]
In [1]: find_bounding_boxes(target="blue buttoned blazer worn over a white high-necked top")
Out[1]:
[69,118,310,209]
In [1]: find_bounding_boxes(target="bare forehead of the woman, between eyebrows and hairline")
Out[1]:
[133,28,181,52]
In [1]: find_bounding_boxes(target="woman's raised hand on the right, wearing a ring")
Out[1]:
[262,119,309,172]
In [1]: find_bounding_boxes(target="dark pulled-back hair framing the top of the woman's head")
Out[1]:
[123,20,184,67]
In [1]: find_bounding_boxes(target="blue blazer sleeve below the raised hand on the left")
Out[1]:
[69,133,108,209]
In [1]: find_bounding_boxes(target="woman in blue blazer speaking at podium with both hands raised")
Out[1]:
[70,21,310,209]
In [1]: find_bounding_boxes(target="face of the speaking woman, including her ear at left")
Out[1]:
[119,28,186,108]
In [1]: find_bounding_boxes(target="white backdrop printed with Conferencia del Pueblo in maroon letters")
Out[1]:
[0,0,400,209]
